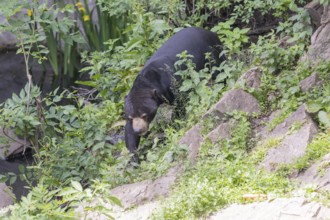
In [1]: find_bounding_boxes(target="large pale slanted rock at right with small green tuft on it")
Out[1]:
[259,105,318,171]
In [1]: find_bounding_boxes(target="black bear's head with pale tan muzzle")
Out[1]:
[125,90,159,136]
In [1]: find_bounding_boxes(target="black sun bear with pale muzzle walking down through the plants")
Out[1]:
[125,27,223,162]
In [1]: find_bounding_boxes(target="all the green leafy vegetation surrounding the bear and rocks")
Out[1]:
[0,0,330,219]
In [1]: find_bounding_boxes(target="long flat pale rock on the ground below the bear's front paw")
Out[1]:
[111,165,182,208]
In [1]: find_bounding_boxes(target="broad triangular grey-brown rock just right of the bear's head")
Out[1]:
[203,89,260,118]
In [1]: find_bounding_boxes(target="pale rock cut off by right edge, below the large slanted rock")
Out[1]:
[297,154,330,190]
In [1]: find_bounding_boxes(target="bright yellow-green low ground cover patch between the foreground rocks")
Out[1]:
[153,114,293,219]
